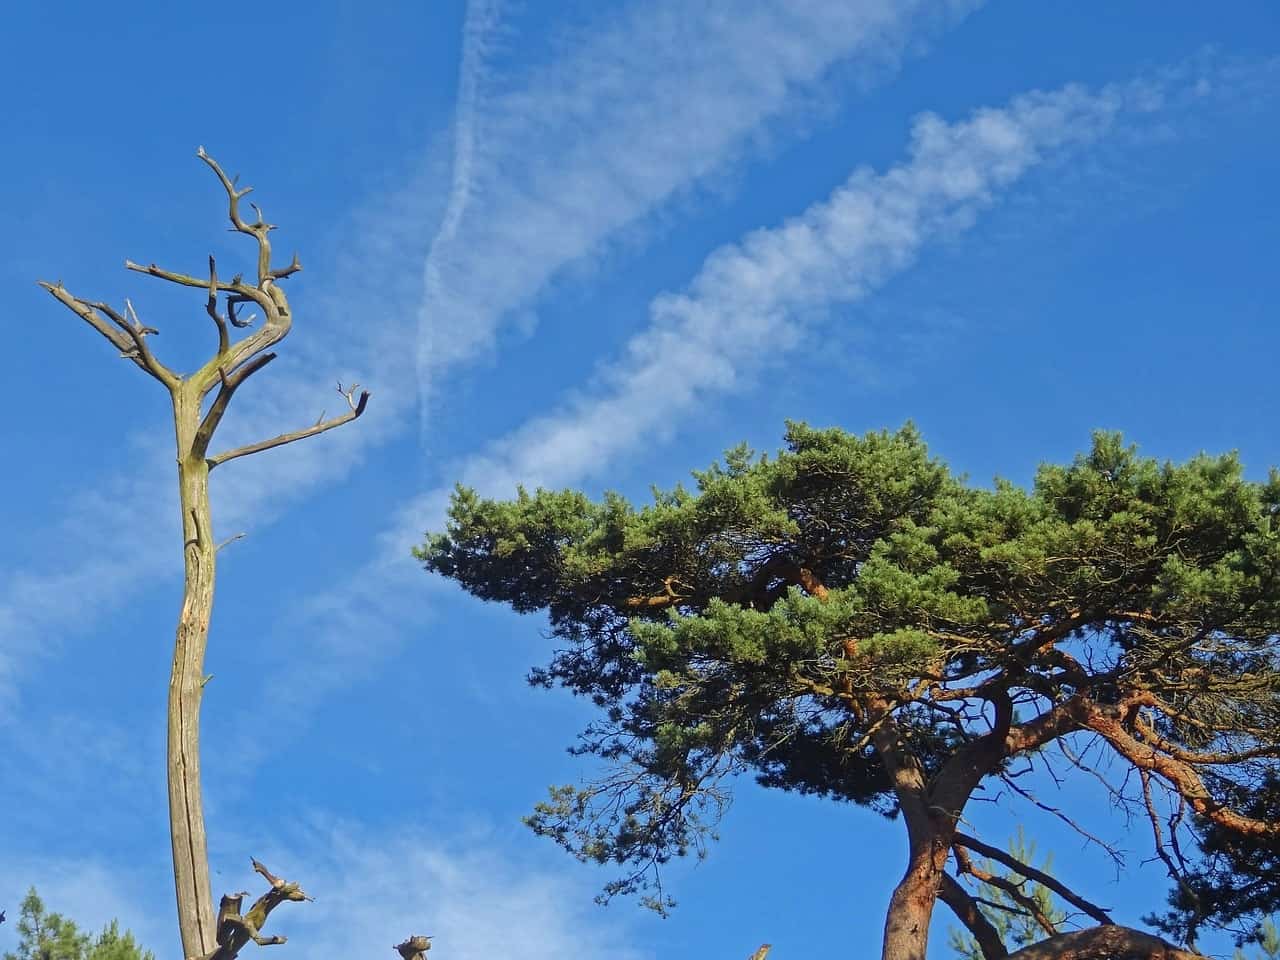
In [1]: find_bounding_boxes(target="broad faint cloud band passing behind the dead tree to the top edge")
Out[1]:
[0,0,977,719]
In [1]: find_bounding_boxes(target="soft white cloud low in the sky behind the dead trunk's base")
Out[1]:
[0,814,652,960]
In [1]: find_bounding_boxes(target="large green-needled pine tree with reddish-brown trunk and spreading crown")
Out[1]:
[417,424,1280,960]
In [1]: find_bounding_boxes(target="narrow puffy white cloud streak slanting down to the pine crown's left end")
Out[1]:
[280,64,1264,705]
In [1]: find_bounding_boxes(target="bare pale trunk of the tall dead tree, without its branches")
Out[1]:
[168,388,218,957]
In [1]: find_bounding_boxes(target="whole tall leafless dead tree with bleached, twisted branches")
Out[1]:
[40,147,369,960]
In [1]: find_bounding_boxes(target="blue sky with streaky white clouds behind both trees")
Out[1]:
[0,0,1280,960]
